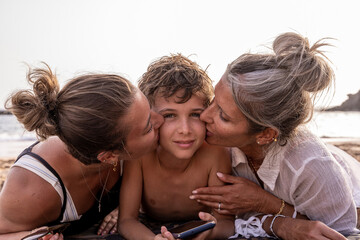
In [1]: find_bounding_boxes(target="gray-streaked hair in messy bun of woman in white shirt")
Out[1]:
[225,33,334,145]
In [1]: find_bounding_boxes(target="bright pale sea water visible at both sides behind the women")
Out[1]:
[0,111,360,159]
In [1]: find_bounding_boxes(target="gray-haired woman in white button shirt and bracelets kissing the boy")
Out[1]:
[191,33,360,239]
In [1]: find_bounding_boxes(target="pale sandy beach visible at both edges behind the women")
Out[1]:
[0,138,360,191]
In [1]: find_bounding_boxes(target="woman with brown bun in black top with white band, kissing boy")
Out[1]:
[0,66,163,240]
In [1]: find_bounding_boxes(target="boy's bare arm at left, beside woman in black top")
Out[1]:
[118,159,155,240]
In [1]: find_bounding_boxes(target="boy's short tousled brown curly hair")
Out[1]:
[138,54,214,106]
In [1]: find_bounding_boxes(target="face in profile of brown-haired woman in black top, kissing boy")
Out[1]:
[120,91,164,159]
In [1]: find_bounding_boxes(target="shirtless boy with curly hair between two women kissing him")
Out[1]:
[118,54,234,239]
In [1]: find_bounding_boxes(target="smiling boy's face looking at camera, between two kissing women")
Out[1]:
[153,92,206,159]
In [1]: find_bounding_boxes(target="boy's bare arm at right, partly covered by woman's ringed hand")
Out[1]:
[208,148,235,239]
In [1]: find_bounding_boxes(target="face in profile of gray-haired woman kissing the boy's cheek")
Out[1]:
[200,75,255,149]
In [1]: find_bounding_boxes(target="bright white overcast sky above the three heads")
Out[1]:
[0,0,360,109]
